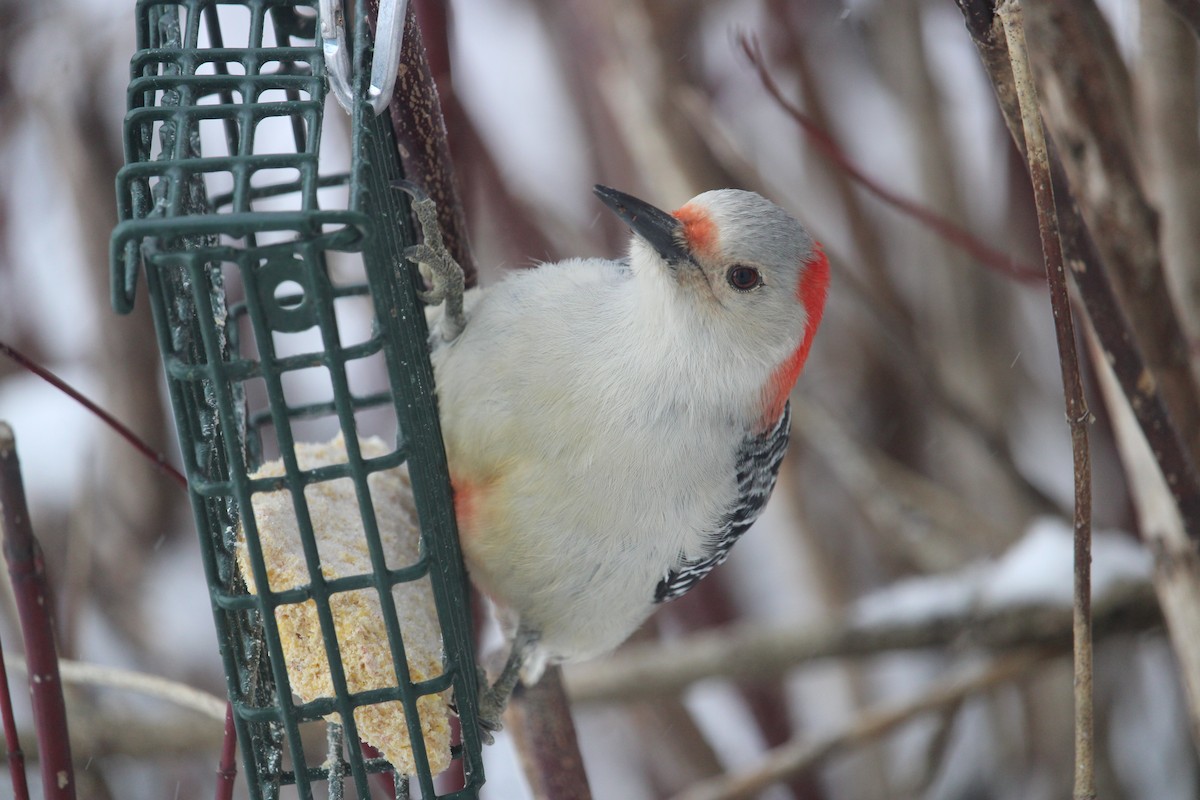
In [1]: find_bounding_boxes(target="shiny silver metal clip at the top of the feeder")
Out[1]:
[319,0,408,115]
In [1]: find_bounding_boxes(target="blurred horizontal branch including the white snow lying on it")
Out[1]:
[565,521,1162,703]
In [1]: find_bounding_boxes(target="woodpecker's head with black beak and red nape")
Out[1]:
[595,186,829,426]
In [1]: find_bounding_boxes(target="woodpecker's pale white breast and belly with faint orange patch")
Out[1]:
[433,260,761,658]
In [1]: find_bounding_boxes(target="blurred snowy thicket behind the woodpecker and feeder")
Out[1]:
[0,0,1200,800]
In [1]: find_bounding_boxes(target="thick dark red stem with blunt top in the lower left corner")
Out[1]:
[0,422,76,800]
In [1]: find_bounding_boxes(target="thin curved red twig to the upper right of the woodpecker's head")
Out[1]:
[740,36,1042,282]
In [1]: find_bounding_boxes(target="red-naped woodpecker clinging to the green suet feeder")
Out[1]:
[404,186,829,739]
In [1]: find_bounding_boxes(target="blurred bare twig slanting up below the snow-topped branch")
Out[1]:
[674,650,1054,800]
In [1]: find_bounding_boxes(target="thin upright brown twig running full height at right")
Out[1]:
[996,0,1096,800]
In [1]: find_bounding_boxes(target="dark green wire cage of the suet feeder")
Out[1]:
[110,0,484,798]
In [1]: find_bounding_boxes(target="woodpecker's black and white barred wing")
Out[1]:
[654,403,792,603]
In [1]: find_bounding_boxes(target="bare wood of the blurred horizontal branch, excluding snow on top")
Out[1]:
[566,583,1162,703]
